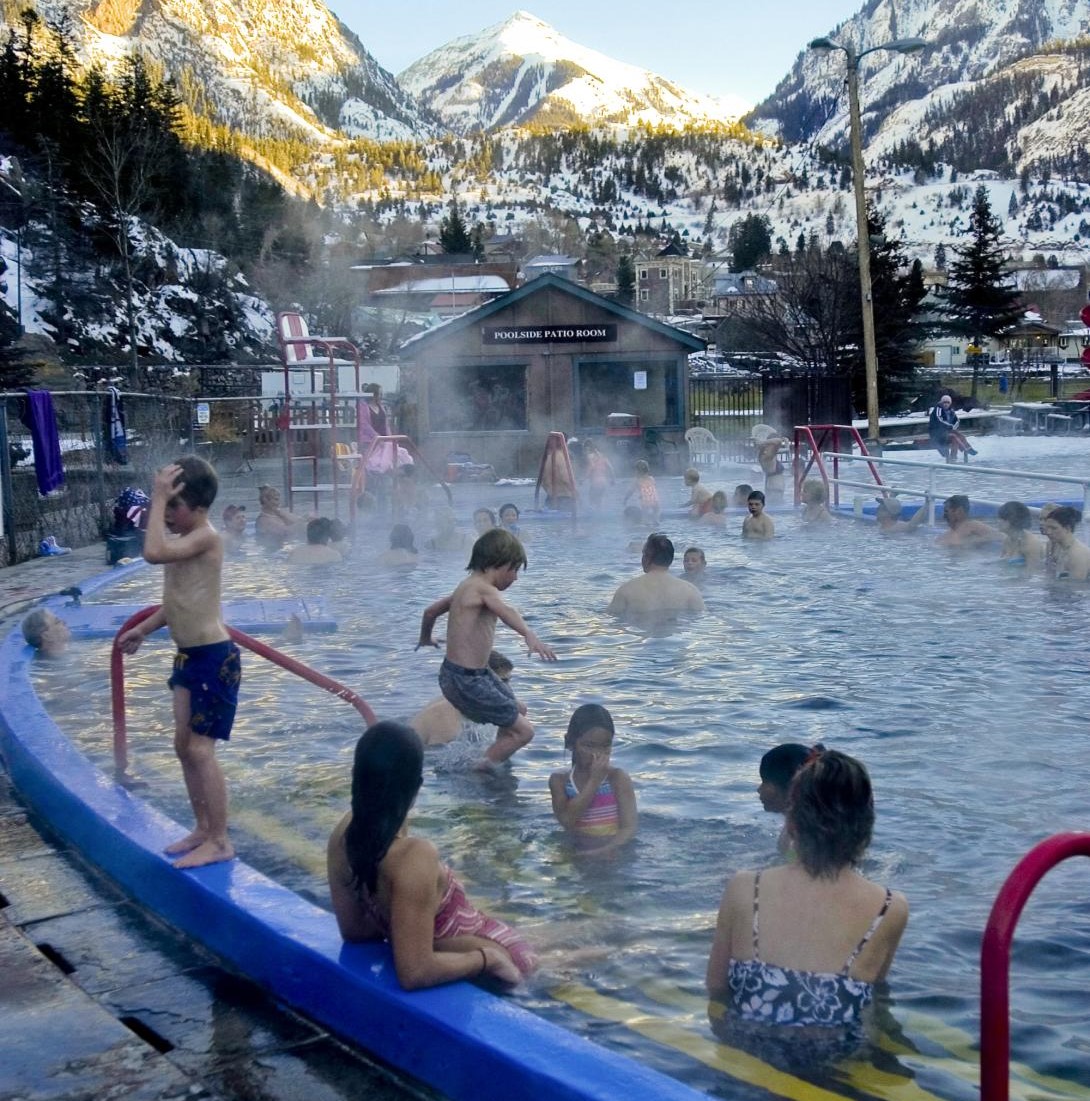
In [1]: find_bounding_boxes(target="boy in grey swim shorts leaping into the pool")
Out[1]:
[415,527,556,764]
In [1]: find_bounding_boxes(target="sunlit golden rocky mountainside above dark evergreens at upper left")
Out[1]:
[5,0,440,143]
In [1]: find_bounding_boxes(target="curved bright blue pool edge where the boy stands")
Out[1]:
[0,585,706,1101]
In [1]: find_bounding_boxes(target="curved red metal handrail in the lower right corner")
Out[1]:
[980,833,1090,1101]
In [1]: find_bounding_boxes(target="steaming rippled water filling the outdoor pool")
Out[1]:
[46,466,1090,1099]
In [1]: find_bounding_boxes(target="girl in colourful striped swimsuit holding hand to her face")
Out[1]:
[548,704,636,852]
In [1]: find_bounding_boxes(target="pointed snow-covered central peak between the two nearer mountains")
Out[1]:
[397,11,748,133]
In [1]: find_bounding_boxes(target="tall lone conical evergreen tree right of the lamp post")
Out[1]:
[941,184,1023,397]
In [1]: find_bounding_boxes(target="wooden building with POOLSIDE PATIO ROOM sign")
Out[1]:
[402,274,705,476]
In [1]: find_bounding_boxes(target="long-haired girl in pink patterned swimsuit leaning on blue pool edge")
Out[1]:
[326,722,536,990]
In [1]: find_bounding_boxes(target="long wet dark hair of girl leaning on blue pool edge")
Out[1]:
[345,722,424,894]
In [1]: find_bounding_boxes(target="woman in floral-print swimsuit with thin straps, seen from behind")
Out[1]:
[707,749,908,1038]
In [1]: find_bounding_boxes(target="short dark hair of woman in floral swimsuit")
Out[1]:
[787,750,874,879]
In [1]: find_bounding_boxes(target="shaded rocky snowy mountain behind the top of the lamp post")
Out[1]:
[751,0,1090,154]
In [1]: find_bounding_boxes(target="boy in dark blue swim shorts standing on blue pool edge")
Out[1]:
[118,455,242,868]
